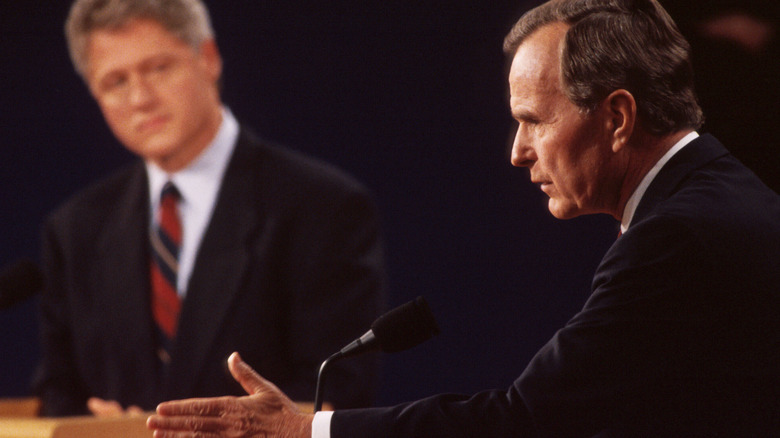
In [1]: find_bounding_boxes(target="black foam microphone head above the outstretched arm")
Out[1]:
[371,297,439,353]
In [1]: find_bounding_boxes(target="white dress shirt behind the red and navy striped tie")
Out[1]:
[146,107,239,298]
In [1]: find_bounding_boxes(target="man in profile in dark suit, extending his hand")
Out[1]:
[148,0,780,438]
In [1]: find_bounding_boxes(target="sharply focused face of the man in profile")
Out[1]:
[509,23,616,219]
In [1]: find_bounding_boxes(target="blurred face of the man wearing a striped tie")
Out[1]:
[86,19,221,172]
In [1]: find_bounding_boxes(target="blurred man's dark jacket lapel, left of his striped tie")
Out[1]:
[90,162,163,399]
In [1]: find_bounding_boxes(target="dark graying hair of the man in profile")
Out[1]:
[504,0,704,135]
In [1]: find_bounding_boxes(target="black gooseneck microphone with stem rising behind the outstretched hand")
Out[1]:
[314,297,439,412]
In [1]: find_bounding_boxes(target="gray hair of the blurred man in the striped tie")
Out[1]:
[65,0,214,77]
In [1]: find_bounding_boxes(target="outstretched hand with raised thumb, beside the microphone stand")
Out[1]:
[147,353,313,438]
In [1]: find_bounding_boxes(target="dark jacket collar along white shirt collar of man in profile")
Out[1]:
[632,134,728,223]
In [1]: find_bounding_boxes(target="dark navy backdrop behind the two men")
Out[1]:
[0,0,772,404]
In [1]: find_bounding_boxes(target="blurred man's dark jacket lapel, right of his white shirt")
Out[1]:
[167,133,259,397]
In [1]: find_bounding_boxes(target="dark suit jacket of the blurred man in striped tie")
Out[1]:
[37,130,385,415]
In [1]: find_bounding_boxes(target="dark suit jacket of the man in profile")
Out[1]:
[331,135,780,438]
